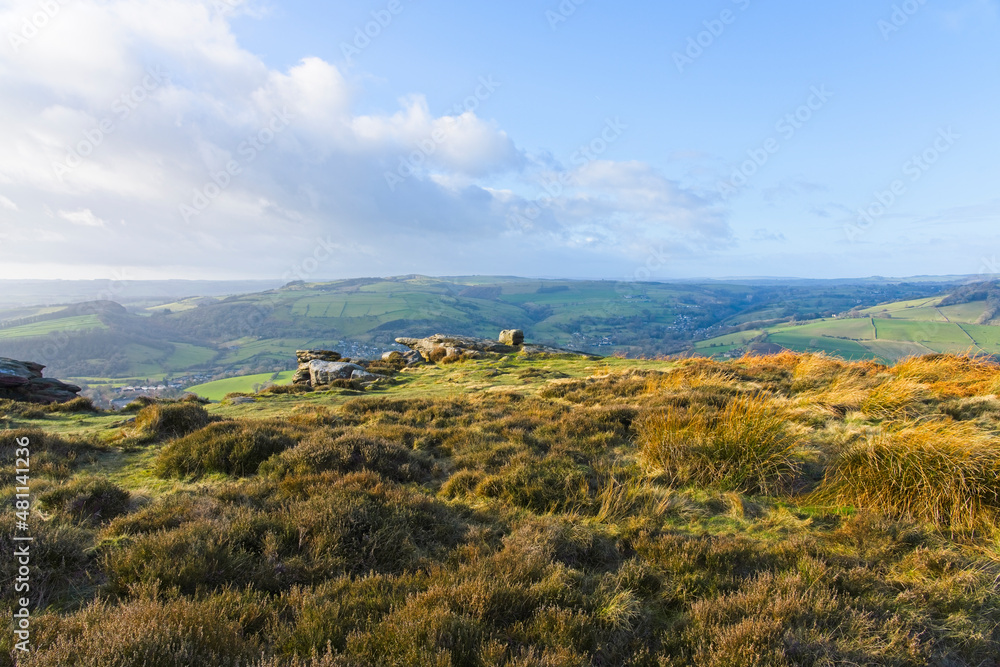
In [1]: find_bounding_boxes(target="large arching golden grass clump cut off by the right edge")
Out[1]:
[817,420,1000,530]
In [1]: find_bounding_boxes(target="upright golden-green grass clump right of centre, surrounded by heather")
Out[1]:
[638,395,798,494]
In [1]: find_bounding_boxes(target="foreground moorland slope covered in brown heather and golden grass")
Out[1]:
[0,353,1000,667]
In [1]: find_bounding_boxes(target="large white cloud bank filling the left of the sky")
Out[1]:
[0,0,729,277]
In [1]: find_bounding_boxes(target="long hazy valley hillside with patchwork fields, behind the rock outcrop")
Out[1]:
[0,276,946,389]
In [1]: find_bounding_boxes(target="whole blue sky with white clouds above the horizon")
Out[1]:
[0,0,1000,281]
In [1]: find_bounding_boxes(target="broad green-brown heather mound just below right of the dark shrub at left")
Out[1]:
[156,421,298,477]
